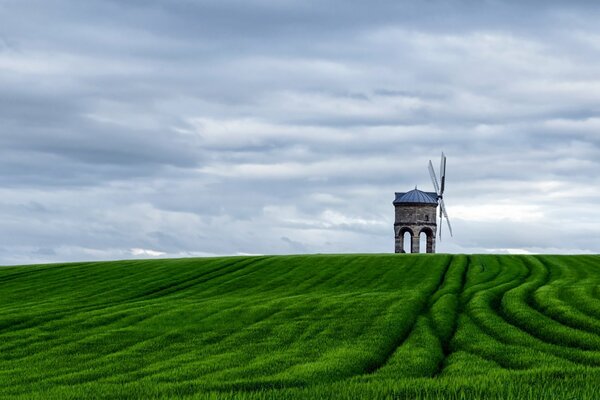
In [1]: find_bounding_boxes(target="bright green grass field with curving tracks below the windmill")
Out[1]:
[0,255,600,399]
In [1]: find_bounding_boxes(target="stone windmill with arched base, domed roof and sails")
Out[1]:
[393,153,452,253]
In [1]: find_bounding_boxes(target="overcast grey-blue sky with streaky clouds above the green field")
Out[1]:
[0,0,600,265]
